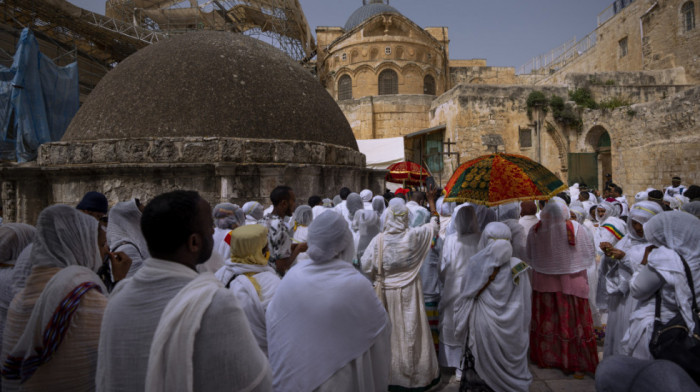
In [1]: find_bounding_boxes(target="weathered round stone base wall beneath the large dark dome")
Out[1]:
[0,138,385,223]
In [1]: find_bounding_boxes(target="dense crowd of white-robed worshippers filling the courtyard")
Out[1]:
[0,180,700,392]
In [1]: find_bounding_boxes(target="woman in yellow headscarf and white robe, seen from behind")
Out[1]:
[216,225,280,354]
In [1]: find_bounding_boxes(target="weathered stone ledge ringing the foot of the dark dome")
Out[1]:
[37,137,366,168]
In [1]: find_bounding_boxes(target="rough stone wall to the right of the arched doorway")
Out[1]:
[574,87,700,201]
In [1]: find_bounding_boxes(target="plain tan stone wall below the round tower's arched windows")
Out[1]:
[338,95,435,139]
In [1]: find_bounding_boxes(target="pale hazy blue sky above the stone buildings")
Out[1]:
[69,0,613,68]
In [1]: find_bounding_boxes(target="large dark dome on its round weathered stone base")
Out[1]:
[0,32,385,223]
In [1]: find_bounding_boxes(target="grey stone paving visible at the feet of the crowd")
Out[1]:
[431,346,603,392]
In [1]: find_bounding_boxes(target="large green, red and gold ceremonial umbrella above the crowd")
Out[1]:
[445,153,567,206]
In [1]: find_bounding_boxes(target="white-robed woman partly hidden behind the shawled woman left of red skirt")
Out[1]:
[438,204,481,378]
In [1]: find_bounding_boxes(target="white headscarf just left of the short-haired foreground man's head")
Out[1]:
[107,199,150,260]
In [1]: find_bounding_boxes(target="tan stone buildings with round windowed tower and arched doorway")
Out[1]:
[316,0,700,195]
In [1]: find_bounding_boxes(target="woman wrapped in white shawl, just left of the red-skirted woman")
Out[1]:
[455,222,532,392]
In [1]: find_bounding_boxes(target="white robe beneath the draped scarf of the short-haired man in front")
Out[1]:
[96,258,272,391]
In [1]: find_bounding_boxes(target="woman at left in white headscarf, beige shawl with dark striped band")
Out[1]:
[0,205,108,392]
